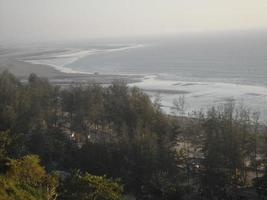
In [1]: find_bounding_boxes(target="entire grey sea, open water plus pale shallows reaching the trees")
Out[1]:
[21,34,267,121]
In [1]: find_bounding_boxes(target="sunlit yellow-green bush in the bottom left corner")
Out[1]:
[0,155,58,200]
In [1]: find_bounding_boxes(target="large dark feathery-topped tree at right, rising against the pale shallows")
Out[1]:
[201,103,256,196]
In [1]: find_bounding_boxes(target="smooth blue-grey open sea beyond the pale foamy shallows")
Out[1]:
[67,36,267,86]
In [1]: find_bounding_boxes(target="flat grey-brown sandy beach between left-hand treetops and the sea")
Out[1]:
[0,50,141,85]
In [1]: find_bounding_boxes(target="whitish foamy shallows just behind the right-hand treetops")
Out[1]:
[130,76,267,121]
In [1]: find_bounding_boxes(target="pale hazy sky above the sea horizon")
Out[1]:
[0,0,267,41]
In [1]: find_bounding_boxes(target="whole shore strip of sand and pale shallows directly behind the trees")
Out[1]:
[0,46,267,121]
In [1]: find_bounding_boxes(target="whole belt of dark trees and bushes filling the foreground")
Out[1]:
[0,71,267,200]
